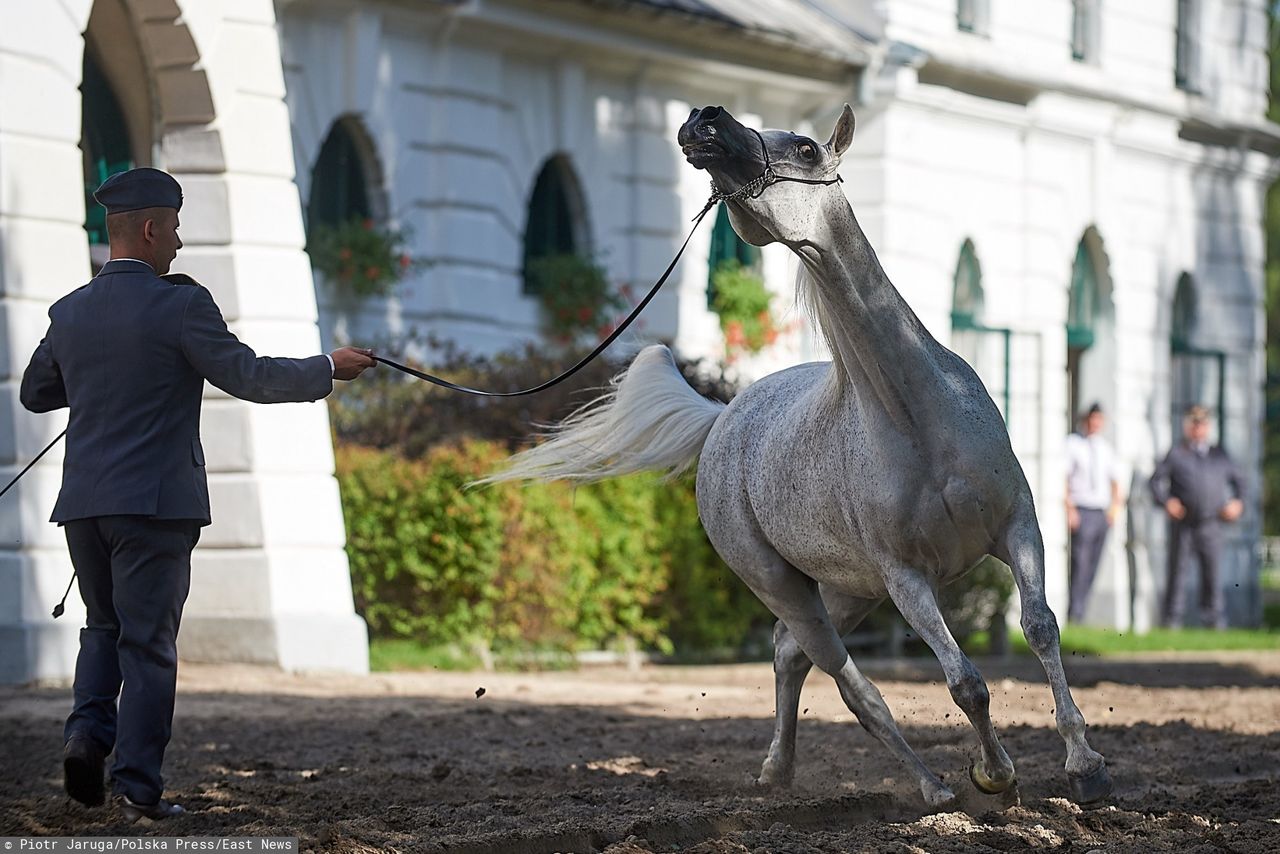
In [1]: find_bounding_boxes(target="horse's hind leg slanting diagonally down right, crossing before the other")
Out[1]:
[730,560,955,807]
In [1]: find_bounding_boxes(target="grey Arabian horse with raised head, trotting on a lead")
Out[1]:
[490,105,1111,807]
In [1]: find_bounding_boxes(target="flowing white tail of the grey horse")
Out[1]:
[479,344,724,483]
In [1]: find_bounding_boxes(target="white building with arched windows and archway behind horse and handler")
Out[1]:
[0,0,1280,680]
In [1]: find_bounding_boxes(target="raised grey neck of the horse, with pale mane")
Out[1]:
[791,196,938,429]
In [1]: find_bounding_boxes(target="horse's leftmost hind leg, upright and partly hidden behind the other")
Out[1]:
[760,586,881,786]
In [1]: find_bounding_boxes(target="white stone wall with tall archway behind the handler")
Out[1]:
[0,0,367,681]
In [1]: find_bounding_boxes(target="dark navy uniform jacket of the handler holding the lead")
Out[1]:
[20,260,333,525]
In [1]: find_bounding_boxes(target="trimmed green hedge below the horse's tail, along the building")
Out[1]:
[337,440,773,653]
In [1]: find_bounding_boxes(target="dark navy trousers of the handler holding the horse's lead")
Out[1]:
[63,516,200,804]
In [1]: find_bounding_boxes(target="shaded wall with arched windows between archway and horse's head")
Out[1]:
[280,0,852,375]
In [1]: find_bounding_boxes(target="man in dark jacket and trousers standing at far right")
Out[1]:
[1151,406,1244,629]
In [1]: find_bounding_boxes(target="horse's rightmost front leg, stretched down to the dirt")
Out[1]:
[996,503,1111,804]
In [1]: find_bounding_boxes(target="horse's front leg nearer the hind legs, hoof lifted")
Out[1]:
[884,570,1014,795]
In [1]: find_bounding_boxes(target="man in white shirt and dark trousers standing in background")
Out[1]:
[1066,403,1124,622]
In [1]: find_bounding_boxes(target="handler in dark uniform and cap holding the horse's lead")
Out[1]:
[20,169,374,821]
